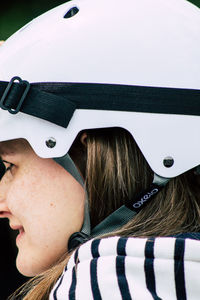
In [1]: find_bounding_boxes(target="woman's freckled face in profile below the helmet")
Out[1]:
[0,140,84,276]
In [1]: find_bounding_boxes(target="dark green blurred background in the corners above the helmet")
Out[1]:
[0,0,200,40]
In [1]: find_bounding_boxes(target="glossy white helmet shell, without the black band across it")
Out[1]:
[0,0,200,177]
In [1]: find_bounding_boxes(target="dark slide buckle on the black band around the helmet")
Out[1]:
[0,76,30,115]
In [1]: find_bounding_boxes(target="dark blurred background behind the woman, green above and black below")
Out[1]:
[0,0,200,300]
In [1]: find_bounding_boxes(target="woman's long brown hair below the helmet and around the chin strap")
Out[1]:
[11,128,200,300]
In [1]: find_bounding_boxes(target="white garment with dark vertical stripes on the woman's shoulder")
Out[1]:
[49,236,200,300]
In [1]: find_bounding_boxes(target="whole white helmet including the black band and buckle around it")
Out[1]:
[0,0,200,178]
